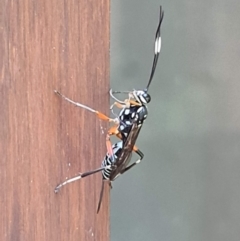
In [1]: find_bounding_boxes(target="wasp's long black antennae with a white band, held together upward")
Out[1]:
[146,6,164,91]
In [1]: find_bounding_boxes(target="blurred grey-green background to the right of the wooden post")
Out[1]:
[111,0,240,241]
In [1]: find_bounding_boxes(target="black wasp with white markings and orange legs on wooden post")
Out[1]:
[54,6,164,212]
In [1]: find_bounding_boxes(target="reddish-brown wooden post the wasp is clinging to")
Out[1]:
[0,0,109,241]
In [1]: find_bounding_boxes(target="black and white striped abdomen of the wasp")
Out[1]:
[101,141,122,180]
